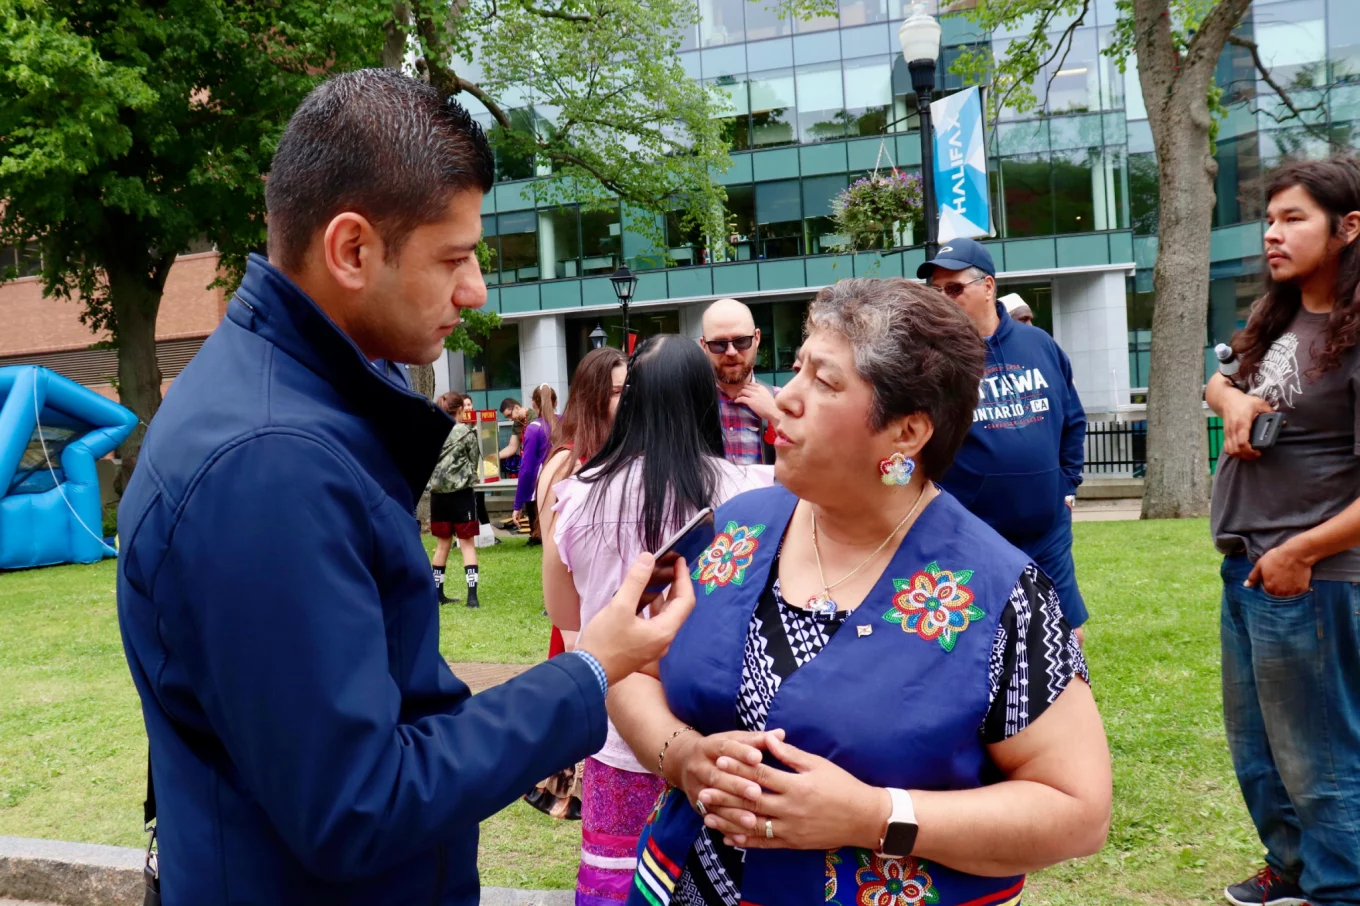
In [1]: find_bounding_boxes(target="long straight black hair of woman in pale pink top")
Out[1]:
[581,333,722,551]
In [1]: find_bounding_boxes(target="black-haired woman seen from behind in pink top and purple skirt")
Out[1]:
[544,335,774,906]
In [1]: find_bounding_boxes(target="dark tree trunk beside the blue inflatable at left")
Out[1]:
[107,257,163,497]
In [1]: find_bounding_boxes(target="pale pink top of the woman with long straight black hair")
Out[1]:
[552,458,774,771]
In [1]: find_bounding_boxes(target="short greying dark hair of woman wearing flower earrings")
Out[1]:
[806,278,987,479]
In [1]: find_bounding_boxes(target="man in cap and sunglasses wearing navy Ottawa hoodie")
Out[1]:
[917,239,1087,638]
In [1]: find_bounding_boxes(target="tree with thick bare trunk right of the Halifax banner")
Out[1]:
[955,0,1338,518]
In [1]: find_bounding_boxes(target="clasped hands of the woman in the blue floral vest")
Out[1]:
[666,729,892,849]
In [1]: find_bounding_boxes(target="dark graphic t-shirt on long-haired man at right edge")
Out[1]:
[1212,309,1360,582]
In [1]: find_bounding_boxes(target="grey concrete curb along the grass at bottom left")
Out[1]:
[0,837,575,906]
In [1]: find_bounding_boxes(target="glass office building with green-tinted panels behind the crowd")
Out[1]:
[437,0,1360,416]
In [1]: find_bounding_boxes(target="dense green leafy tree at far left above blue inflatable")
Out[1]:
[0,0,386,476]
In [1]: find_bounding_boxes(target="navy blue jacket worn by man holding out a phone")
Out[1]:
[118,256,605,906]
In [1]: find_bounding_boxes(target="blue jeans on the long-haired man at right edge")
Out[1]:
[1221,554,1360,906]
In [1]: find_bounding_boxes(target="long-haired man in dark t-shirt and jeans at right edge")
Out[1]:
[1205,159,1360,906]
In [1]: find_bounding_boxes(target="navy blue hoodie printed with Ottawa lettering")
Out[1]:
[940,302,1087,544]
